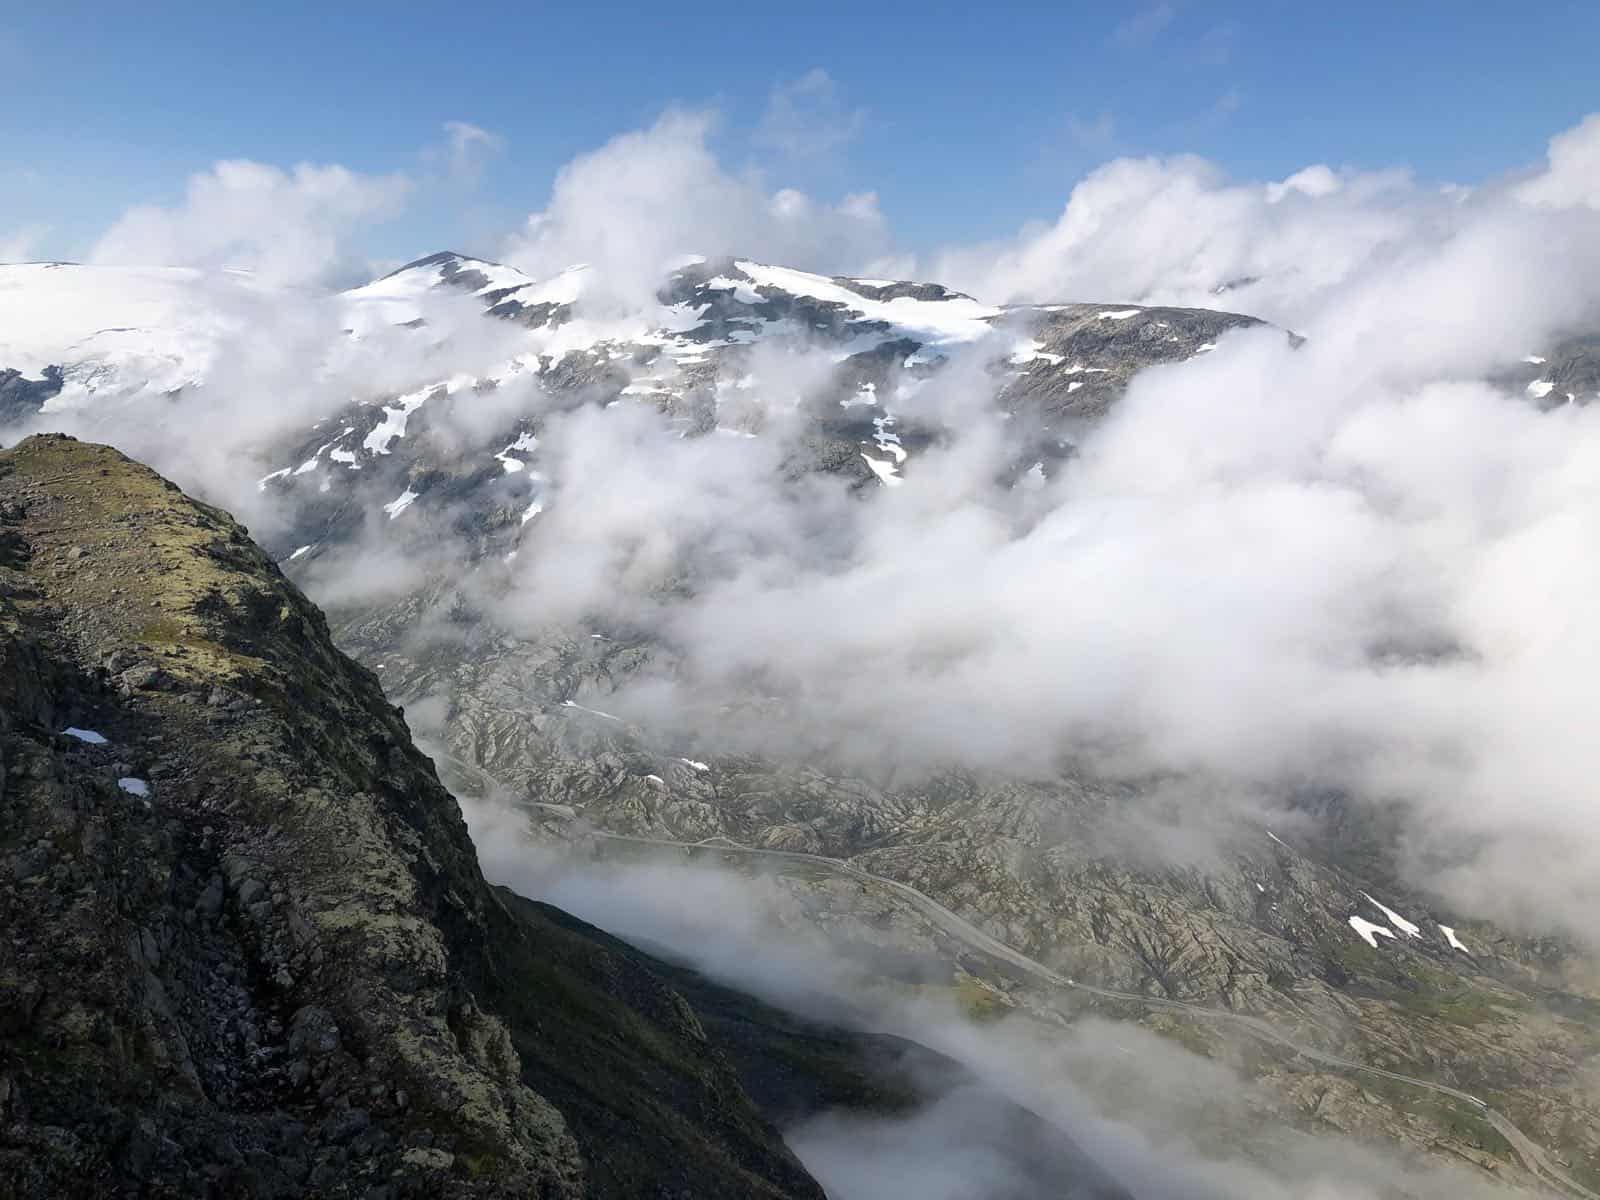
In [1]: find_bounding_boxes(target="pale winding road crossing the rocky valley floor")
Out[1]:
[434,750,1600,1200]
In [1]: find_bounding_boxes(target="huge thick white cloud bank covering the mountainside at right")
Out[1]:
[473,110,1600,936]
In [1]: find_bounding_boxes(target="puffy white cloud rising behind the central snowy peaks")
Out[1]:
[506,110,890,309]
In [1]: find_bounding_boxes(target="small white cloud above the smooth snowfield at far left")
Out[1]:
[90,158,411,285]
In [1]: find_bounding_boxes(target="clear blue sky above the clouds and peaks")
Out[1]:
[0,0,1600,268]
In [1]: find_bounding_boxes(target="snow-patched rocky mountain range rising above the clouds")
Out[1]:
[0,253,1253,550]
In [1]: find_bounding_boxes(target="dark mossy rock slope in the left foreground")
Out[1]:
[0,437,821,1198]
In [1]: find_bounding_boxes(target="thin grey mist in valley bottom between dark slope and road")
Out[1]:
[462,797,1501,1200]
